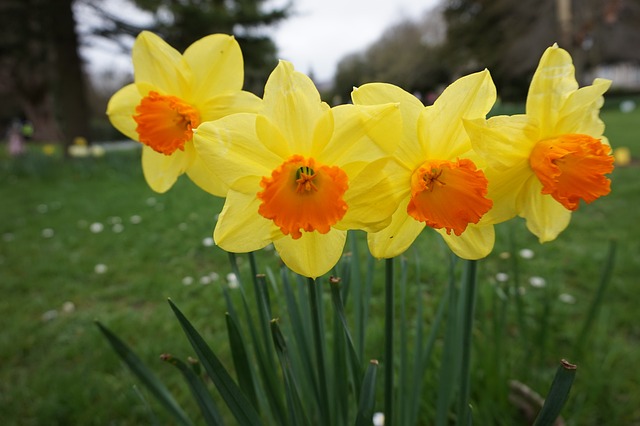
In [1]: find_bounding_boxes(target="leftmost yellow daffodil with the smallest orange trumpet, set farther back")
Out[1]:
[107,31,260,196]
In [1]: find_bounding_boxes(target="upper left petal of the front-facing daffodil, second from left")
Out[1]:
[193,114,282,195]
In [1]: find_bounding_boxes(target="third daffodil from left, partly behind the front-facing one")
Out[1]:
[352,70,496,259]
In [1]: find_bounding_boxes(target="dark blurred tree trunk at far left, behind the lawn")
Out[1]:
[48,0,90,152]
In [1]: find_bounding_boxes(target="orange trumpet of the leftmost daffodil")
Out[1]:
[133,92,200,155]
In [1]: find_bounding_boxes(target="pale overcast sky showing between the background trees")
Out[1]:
[80,0,438,82]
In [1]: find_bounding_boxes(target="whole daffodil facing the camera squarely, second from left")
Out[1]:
[194,61,401,278]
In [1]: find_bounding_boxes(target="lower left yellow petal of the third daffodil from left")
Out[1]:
[367,194,425,259]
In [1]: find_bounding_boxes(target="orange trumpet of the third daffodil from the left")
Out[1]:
[407,159,493,236]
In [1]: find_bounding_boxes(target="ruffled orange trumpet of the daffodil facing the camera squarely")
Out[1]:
[257,155,349,239]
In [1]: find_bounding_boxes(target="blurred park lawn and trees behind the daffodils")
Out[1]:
[0,0,640,425]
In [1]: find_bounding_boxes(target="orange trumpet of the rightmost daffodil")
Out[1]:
[529,134,613,210]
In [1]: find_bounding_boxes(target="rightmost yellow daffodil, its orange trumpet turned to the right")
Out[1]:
[465,45,613,242]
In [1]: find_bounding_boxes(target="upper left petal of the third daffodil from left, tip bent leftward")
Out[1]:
[351,83,424,169]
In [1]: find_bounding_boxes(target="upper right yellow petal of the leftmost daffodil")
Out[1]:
[184,34,248,102]
